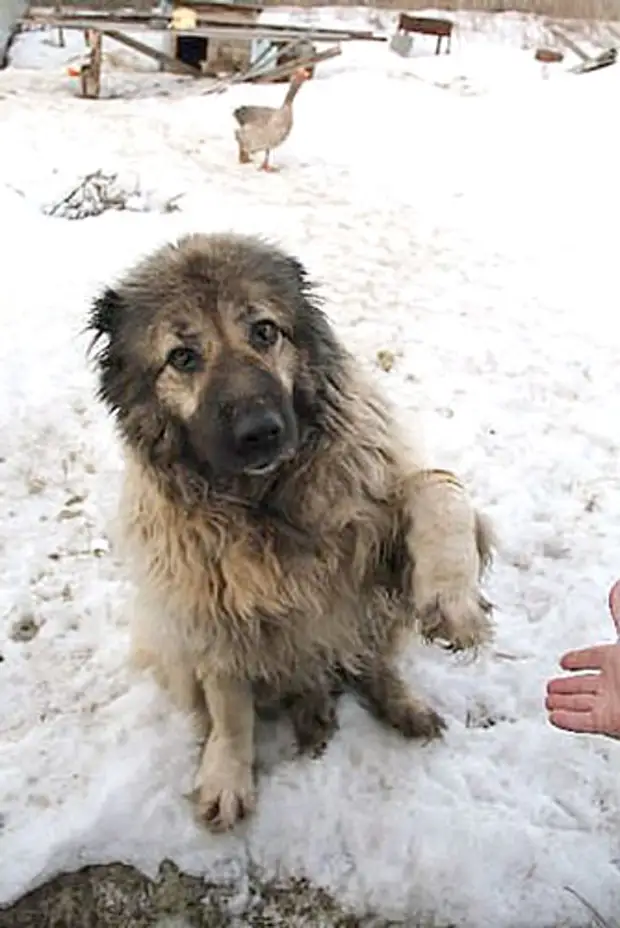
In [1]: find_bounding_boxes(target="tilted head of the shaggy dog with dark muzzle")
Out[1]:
[89,235,342,483]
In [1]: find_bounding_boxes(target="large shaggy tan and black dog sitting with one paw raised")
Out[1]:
[90,235,491,829]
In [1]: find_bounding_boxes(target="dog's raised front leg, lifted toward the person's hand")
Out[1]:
[408,470,493,650]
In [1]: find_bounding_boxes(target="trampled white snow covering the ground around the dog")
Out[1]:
[0,11,620,928]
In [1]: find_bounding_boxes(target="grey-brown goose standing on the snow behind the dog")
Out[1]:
[233,69,308,171]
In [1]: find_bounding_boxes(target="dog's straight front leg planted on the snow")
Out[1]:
[191,674,256,831]
